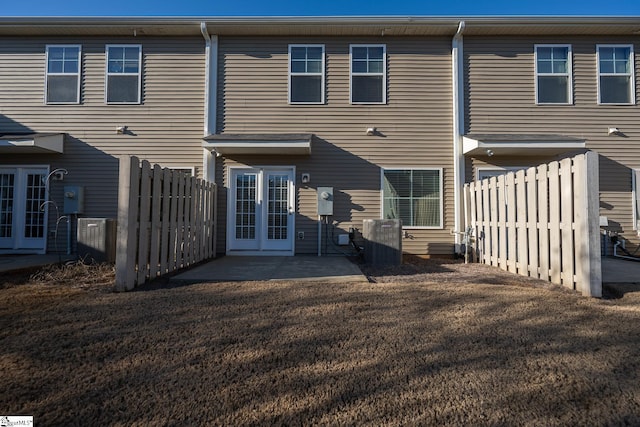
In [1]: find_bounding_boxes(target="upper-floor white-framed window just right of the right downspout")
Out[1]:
[535,44,573,104]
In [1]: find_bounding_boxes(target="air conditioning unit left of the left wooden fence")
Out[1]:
[78,218,116,262]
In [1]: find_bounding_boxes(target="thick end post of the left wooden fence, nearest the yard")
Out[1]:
[116,156,140,292]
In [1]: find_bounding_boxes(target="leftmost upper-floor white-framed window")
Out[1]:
[45,45,82,104]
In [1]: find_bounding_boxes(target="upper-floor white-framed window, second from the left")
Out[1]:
[105,44,142,104]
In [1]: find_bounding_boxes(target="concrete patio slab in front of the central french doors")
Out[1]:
[170,256,367,283]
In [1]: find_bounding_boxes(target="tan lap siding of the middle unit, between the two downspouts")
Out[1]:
[218,37,453,254]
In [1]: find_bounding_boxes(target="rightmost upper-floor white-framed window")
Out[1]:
[596,45,636,104]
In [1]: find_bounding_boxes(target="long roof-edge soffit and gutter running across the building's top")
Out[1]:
[0,16,640,37]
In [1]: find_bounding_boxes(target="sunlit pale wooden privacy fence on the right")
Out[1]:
[464,152,602,297]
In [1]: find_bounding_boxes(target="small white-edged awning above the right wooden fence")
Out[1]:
[462,134,586,157]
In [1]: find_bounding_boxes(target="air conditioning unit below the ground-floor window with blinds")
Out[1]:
[362,219,402,266]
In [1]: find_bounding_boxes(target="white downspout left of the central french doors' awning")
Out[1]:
[200,22,218,182]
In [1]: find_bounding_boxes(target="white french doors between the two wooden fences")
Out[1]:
[227,167,295,255]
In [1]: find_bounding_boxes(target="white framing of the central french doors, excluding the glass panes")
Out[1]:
[226,165,297,256]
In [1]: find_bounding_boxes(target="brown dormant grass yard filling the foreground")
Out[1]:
[0,261,640,426]
